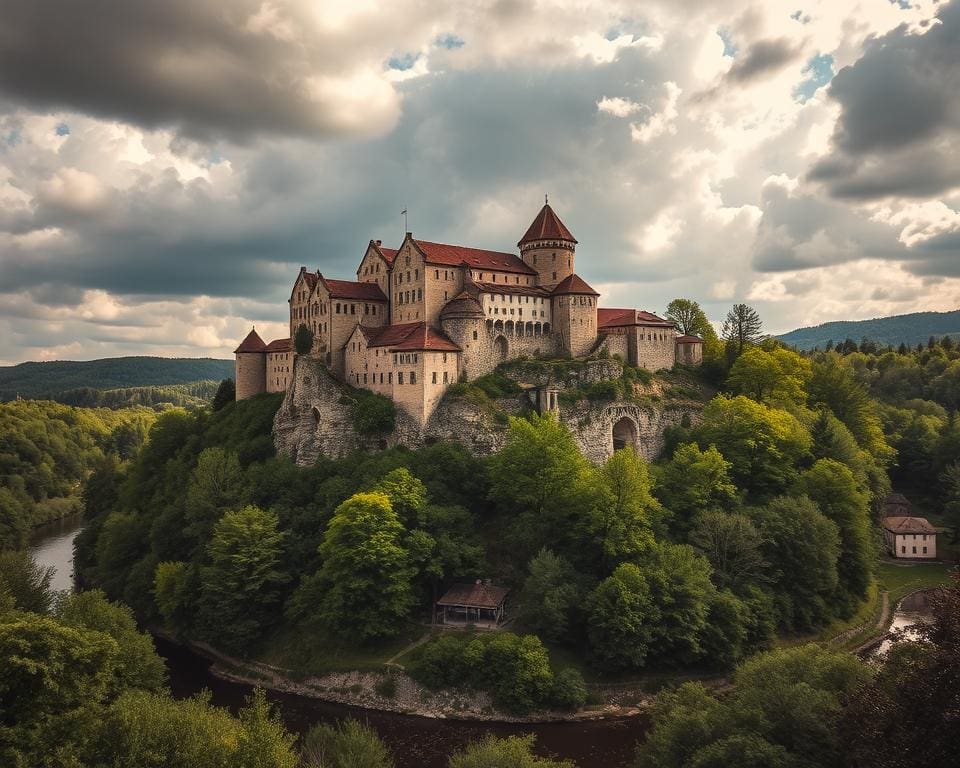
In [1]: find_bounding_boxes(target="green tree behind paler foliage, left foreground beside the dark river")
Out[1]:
[54,589,167,697]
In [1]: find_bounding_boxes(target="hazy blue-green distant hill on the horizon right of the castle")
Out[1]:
[777,309,960,349]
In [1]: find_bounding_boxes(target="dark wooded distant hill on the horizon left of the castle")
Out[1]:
[0,357,233,401]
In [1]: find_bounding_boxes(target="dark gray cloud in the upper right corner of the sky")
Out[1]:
[809,0,960,200]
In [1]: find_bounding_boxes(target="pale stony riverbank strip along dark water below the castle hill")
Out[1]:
[163,630,654,724]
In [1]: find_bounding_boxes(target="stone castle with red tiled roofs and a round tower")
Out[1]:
[235,203,703,425]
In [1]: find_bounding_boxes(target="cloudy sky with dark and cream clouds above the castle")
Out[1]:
[0,0,960,364]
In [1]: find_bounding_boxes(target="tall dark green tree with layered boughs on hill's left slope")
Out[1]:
[200,506,289,652]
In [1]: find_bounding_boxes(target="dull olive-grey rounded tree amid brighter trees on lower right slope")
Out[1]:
[690,510,767,591]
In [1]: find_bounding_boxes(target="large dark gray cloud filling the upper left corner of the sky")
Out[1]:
[0,0,400,138]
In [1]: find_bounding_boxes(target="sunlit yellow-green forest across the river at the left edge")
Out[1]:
[0,400,156,550]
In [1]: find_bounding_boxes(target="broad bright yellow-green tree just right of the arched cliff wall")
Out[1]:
[695,395,810,497]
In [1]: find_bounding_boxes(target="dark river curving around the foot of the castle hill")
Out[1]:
[31,510,647,768]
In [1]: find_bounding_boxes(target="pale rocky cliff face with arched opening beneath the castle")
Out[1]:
[273,356,702,465]
